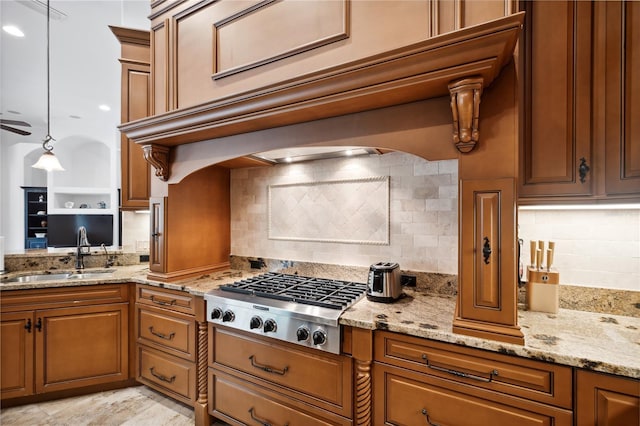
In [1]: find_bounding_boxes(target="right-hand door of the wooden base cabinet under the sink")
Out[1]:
[35,303,129,393]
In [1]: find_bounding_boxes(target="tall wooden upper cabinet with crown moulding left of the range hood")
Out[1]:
[111,27,151,210]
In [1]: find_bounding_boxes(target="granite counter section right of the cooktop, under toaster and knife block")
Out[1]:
[340,289,640,378]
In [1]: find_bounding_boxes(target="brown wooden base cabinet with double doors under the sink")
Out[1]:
[0,285,129,399]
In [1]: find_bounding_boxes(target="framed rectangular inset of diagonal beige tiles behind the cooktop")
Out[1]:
[268,176,389,245]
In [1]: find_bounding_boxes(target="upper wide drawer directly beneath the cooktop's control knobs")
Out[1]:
[210,327,353,417]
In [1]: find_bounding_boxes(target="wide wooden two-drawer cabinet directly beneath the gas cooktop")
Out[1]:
[209,325,353,425]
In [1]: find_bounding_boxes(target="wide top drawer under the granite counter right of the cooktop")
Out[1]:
[374,332,573,409]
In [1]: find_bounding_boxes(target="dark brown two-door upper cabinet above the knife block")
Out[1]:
[519,1,640,204]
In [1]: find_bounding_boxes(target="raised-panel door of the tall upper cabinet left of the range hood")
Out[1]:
[120,64,151,210]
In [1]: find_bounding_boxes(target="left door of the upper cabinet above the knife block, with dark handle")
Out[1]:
[519,1,594,202]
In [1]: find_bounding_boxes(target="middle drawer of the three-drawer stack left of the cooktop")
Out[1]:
[136,304,197,361]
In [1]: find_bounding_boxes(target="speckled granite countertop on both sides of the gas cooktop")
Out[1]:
[0,264,640,378]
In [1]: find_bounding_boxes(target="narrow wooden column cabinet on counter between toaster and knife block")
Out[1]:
[453,178,524,344]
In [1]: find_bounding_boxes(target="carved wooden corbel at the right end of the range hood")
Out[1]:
[449,77,484,153]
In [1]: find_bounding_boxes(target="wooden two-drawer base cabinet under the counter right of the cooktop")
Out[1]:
[373,332,573,425]
